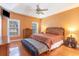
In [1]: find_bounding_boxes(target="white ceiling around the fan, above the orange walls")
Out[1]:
[0,3,79,18]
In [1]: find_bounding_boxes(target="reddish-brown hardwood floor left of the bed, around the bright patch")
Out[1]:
[9,41,31,56]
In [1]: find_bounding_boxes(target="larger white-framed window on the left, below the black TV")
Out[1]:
[8,20,20,36]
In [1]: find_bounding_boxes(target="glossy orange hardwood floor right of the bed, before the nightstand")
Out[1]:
[42,45,79,56]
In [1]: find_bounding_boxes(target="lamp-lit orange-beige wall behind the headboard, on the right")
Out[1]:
[42,7,79,40]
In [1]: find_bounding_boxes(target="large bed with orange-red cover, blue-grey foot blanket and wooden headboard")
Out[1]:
[21,27,64,56]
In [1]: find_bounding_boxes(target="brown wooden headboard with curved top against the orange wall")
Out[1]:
[46,27,65,35]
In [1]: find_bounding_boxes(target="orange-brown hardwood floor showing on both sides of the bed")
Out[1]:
[9,41,79,56]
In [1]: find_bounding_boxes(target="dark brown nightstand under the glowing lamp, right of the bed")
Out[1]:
[64,37,77,48]
